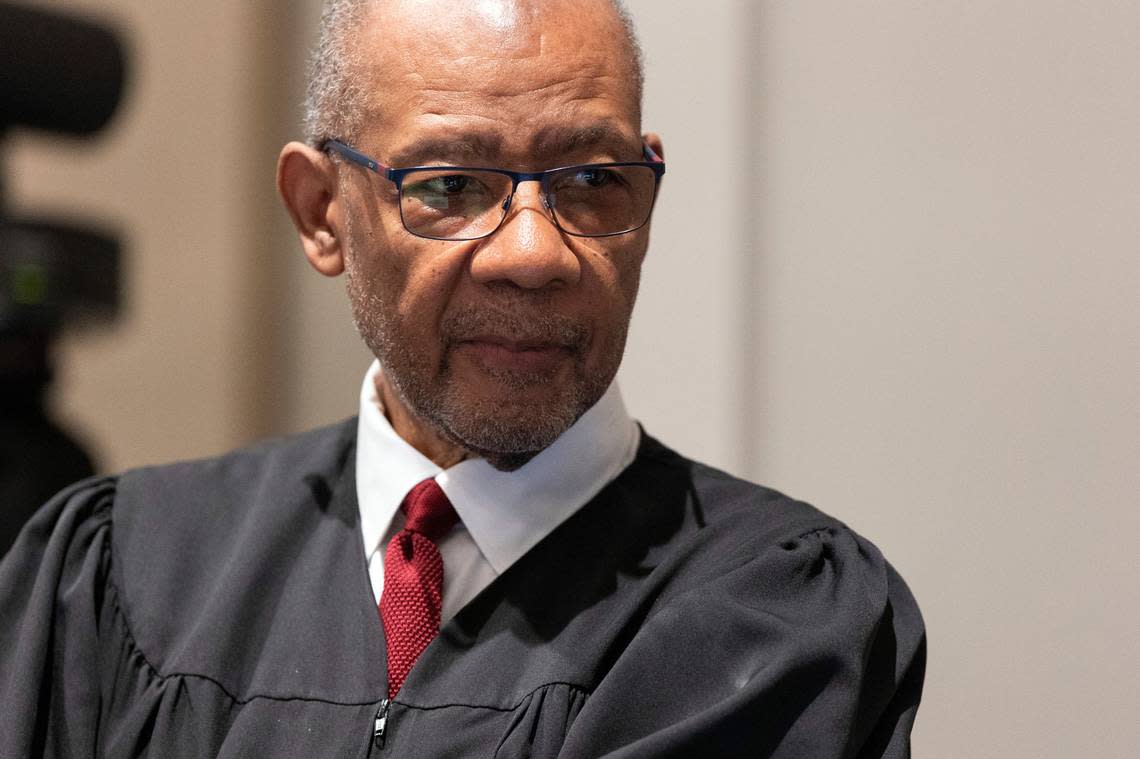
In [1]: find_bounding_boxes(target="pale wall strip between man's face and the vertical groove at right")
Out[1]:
[618,0,756,472]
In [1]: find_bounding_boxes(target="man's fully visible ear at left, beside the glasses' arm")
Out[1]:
[277,142,344,277]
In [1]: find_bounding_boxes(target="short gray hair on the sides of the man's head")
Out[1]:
[304,0,645,147]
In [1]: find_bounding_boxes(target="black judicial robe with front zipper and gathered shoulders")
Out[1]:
[0,421,925,759]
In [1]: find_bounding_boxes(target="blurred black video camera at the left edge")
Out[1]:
[0,2,127,554]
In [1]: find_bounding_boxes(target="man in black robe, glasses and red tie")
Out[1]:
[0,0,925,758]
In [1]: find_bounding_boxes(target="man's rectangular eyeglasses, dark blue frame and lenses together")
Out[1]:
[323,140,665,240]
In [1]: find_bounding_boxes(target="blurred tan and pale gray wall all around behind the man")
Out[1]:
[0,0,1140,759]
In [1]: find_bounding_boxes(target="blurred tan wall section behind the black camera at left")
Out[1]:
[6,0,289,470]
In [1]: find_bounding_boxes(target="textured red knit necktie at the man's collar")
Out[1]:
[380,480,459,699]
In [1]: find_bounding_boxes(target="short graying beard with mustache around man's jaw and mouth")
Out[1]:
[345,234,625,471]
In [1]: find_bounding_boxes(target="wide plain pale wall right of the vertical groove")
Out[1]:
[752,0,1140,759]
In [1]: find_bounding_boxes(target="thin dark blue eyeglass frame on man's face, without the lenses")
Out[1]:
[320,139,665,242]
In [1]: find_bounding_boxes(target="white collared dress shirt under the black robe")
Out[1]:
[356,361,641,621]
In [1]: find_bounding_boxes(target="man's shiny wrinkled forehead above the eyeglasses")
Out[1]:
[357,0,640,165]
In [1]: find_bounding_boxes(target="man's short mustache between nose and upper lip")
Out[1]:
[440,305,589,351]
